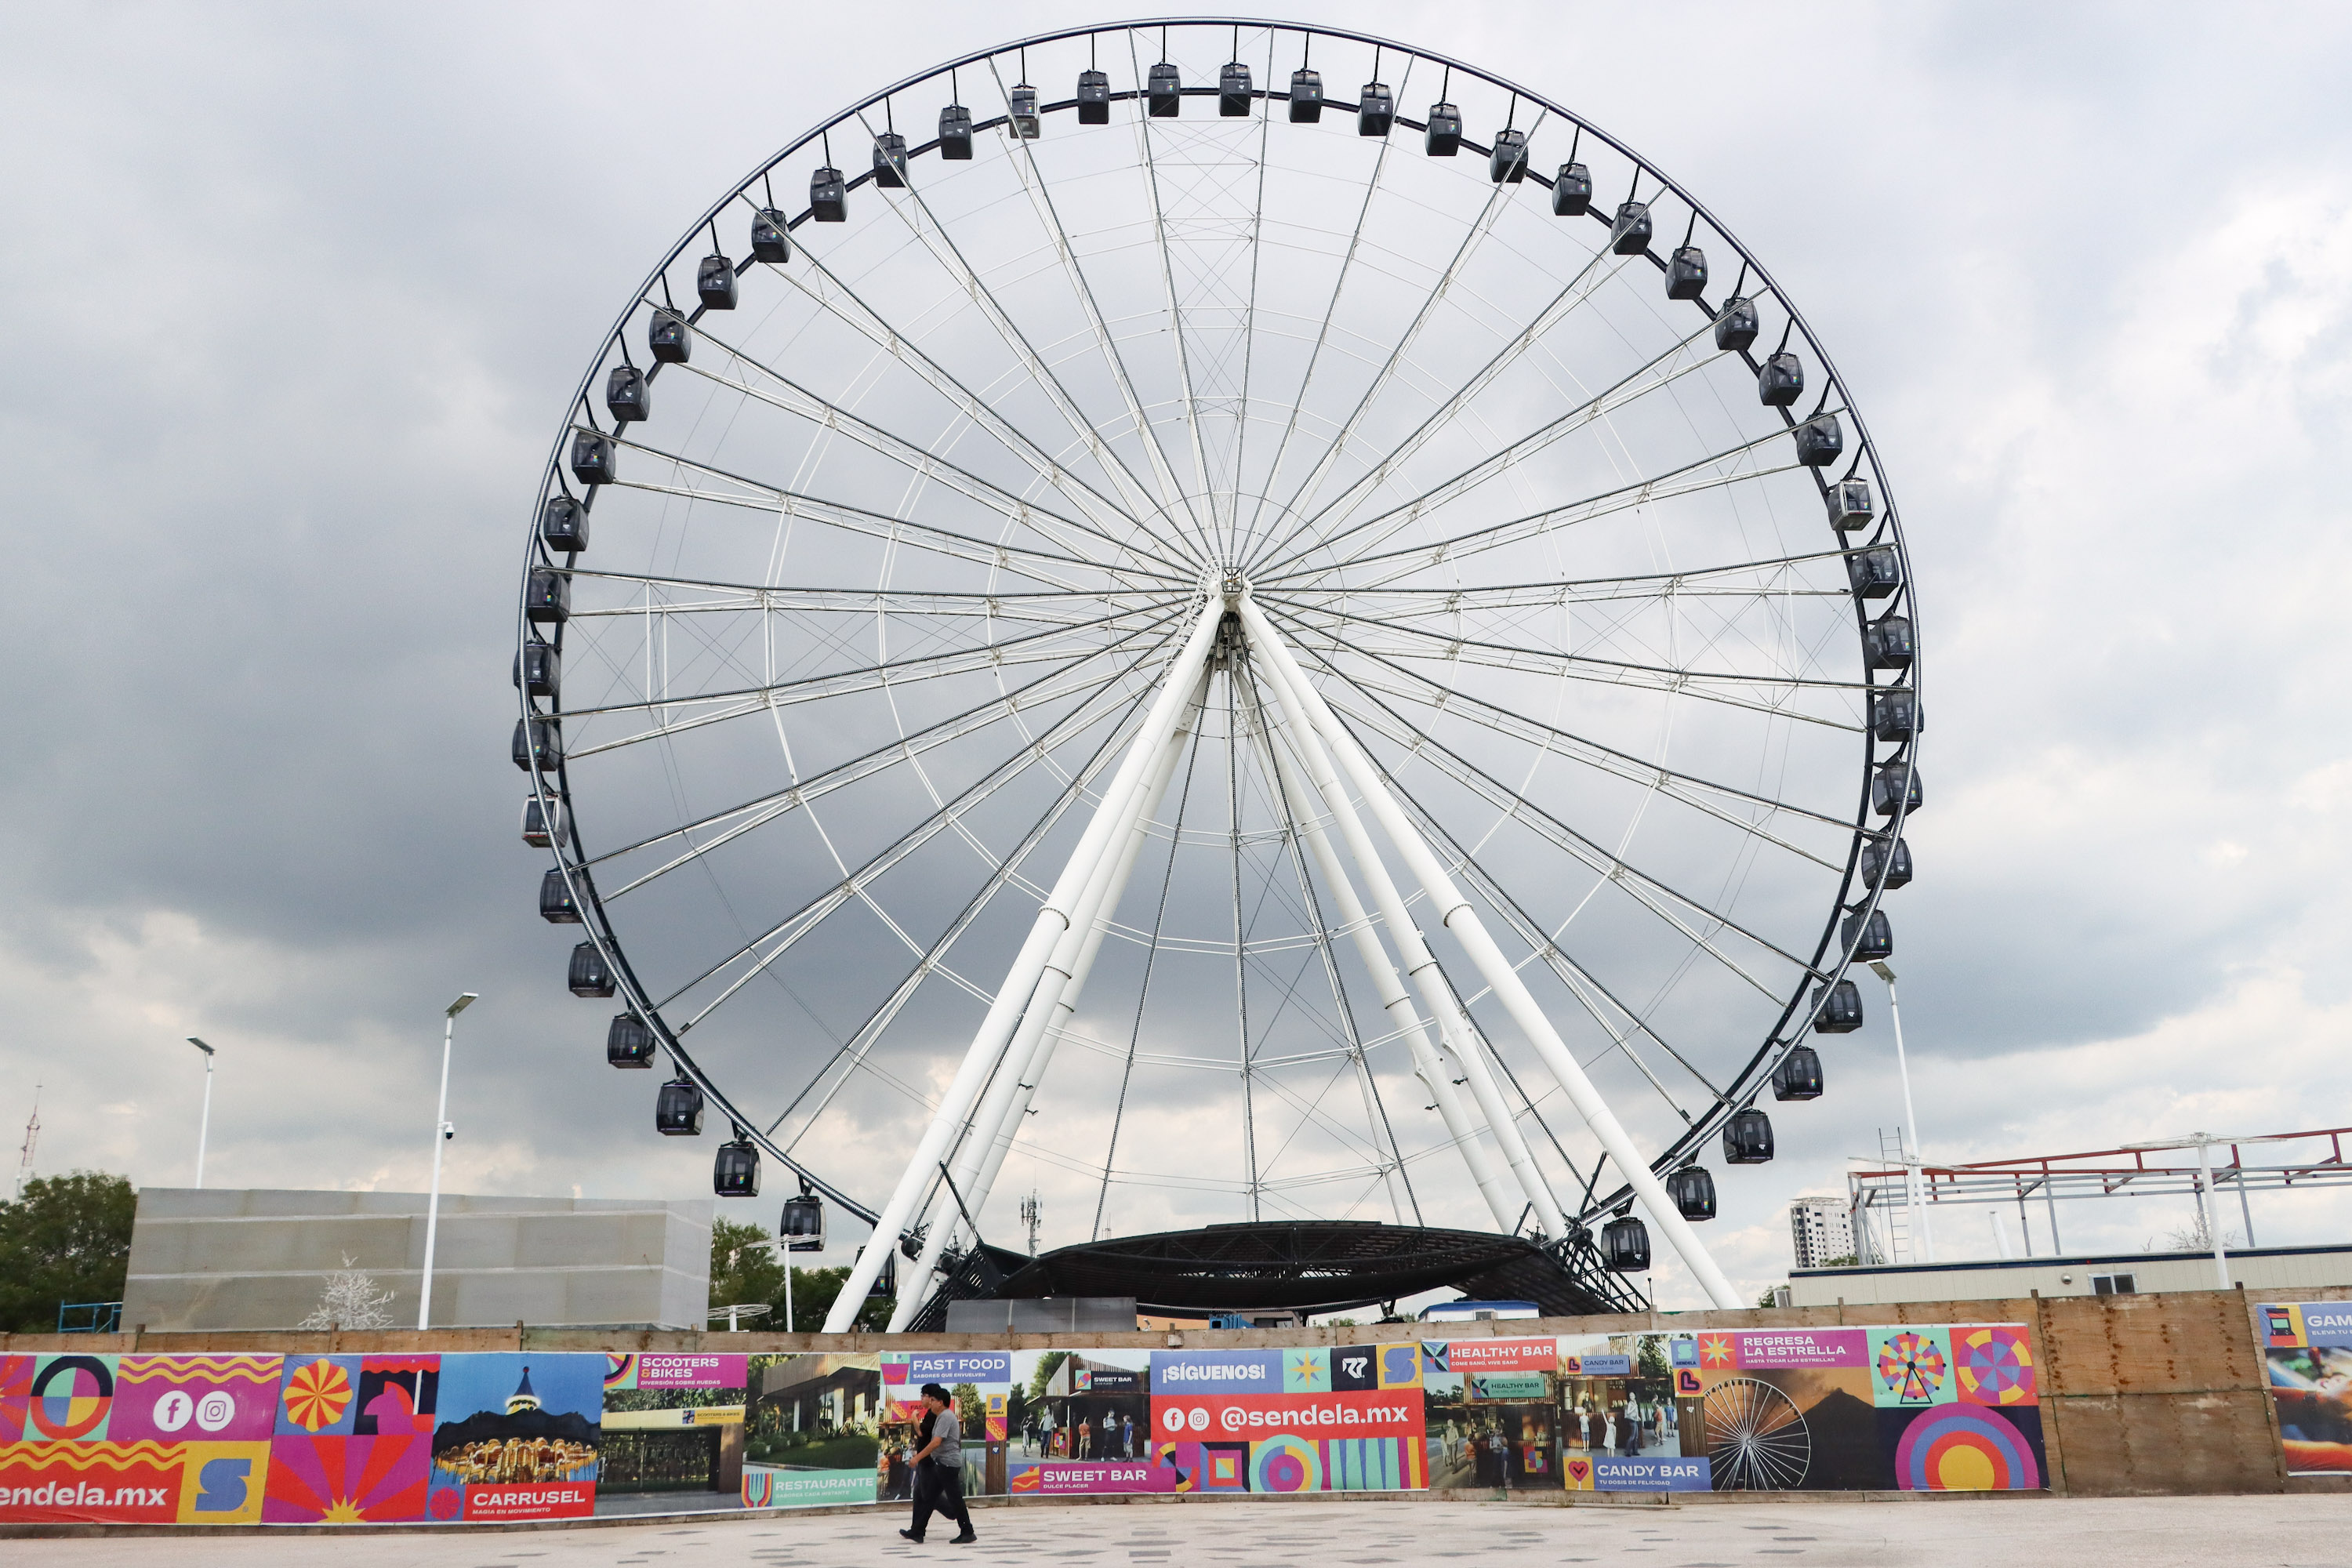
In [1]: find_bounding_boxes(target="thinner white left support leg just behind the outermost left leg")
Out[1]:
[889,670,1209,1333]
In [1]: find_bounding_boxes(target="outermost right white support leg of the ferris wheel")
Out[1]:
[1240,593,1745,1309]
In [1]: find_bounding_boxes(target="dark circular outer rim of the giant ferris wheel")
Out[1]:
[517,16,1924,1305]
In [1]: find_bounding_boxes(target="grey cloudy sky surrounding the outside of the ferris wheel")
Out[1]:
[0,5,2352,1302]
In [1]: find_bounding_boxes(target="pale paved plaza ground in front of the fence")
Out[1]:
[13,1495,2352,1568]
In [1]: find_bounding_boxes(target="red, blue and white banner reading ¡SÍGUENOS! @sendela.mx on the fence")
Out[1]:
[1148,1342,1430,1493]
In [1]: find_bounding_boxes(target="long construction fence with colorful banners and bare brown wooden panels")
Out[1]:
[0,1290,2352,1526]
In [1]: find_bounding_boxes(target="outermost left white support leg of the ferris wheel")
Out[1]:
[826,595,1225,1333]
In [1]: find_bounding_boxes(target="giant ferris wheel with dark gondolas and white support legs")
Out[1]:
[515,21,1919,1328]
